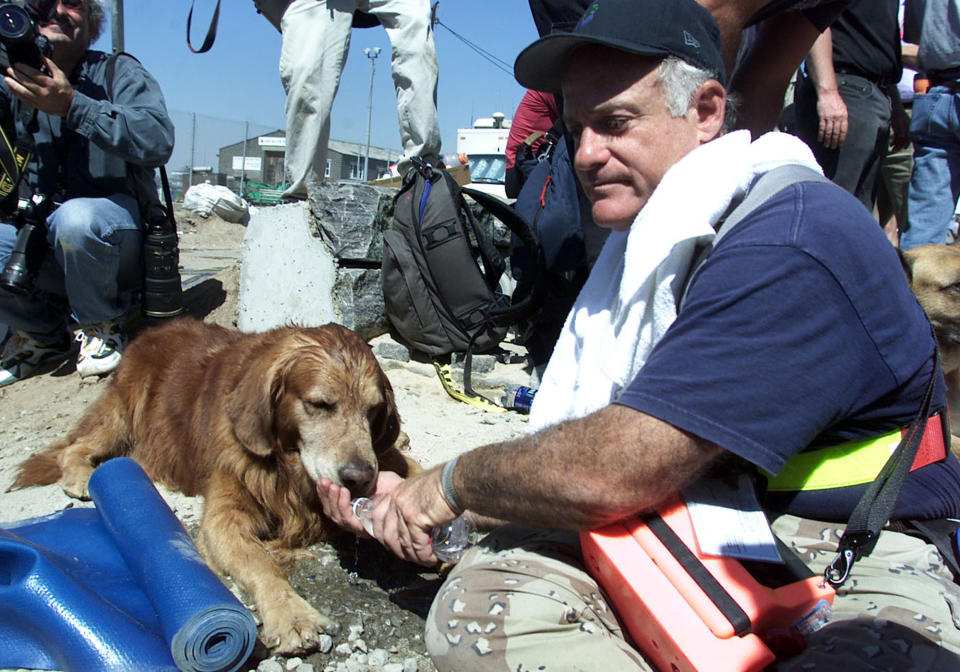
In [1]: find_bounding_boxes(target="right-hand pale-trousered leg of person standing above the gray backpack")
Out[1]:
[368,0,440,174]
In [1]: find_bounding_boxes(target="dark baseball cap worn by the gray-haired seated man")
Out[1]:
[513,0,726,93]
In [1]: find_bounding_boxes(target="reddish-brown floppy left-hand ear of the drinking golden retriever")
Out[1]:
[226,346,283,456]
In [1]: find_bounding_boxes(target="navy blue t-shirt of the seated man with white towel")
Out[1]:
[617,183,960,521]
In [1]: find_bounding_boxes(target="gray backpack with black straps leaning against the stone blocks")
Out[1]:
[382,160,540,392]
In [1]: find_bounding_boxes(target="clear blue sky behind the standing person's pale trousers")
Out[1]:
[94,0,536,169]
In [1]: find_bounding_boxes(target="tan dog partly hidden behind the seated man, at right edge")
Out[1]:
[900,245,960,453]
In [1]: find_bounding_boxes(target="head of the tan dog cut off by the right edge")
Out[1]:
[900,245,960,370]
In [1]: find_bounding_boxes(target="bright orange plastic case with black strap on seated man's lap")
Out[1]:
[581,501,834,672]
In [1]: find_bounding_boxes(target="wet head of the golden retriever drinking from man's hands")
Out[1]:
[227,324,401,496]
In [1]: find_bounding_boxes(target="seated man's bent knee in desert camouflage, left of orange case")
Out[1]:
[424,525,652,672]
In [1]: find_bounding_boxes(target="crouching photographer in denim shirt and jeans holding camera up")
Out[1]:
[0,0,174,385]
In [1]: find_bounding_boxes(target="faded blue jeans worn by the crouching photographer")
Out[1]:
[0,195,143,338]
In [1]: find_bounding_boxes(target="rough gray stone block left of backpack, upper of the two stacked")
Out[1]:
[310,183,398,266]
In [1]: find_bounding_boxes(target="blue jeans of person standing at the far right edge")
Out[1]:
[900,86,960,250]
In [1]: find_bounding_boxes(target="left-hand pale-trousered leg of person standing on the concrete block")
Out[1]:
[280,0,357,198]
